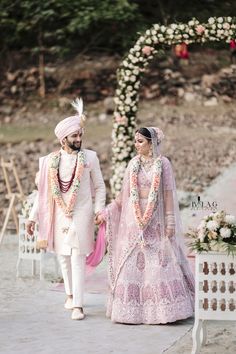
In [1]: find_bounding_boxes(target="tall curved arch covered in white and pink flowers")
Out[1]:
[110,17,236,196]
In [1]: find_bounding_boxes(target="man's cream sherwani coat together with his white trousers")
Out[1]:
[29,149,106,307]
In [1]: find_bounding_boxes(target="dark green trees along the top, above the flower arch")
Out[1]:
[0,0,236,55]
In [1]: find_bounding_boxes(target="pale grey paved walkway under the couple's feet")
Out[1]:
[0,235,193,354]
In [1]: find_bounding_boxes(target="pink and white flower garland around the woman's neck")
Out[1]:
[130,156,162,230]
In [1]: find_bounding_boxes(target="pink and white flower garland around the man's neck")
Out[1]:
[49,151,85,217]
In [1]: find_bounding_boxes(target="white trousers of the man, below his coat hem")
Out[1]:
[58,248,86,307]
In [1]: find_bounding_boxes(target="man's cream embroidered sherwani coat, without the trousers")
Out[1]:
[29,149,106,255]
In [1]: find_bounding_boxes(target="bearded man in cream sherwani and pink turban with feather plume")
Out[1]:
[26,99,106,320]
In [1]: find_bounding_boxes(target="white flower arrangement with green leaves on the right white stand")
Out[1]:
[187,211,236,255]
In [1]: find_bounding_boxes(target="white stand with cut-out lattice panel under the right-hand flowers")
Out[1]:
[192,252,236,354]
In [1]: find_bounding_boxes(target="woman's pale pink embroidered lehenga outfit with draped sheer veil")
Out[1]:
[106,127,194,324]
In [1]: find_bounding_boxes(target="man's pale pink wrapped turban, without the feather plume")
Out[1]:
[54,115,82,141]
